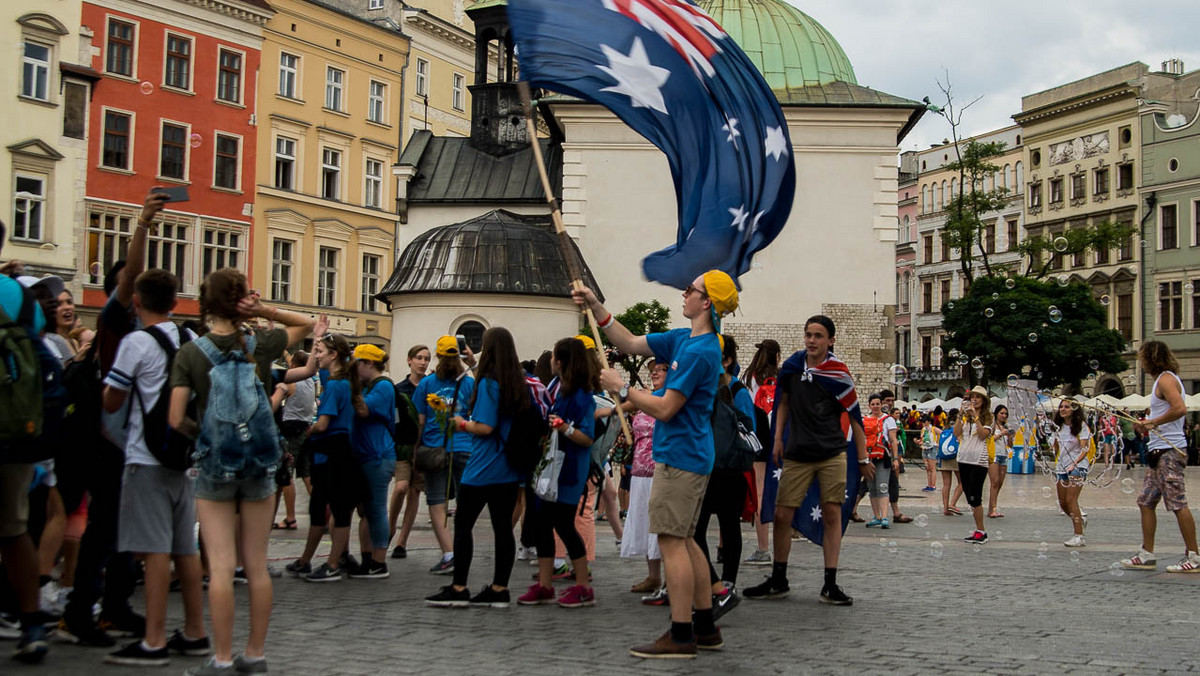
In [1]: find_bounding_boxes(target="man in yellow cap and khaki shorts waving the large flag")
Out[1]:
[572,270,738,658]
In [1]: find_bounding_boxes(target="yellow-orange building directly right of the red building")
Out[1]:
[252,0,409,347]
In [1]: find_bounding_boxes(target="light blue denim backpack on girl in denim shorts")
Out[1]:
[192,333,281,480]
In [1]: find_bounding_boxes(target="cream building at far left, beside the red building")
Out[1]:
[0,5,100,288]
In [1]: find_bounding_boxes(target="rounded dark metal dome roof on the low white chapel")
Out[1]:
[376,209,600,303]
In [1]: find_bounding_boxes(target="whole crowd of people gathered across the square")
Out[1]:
[0,191,1200,676]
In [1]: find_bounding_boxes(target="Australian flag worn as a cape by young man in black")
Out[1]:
[760,351,863,545]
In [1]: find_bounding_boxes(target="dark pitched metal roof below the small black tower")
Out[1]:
[398,130,563,203]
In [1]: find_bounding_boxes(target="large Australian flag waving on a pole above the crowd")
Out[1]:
[508,0,796,288]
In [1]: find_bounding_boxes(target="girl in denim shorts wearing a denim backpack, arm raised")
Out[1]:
[168,268,314,674]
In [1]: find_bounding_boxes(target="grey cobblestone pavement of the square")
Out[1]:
[14,467,1200,676]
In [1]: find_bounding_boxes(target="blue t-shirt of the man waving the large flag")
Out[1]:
[646,329,721,474]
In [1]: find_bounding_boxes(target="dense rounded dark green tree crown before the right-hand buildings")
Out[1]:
[942,276,1128,388]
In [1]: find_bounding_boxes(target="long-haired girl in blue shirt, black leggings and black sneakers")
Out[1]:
[425,327,533,608]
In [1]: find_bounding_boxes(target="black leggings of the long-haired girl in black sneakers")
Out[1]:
[454,483,517,587]
